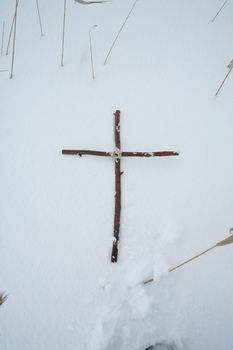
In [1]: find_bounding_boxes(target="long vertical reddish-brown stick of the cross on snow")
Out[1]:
[111,111,121,263]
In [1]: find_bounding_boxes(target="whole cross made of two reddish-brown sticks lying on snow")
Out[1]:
[62,110,179,263]
